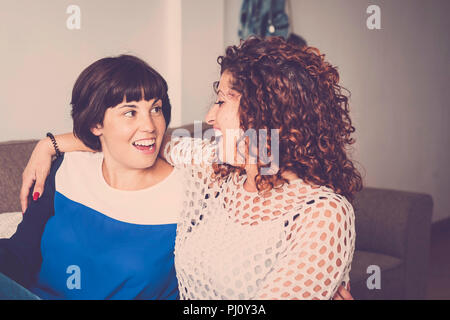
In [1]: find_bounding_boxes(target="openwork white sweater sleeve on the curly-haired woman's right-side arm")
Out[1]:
[255,195,355,300]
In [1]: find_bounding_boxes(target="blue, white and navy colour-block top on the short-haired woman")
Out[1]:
[0,152,182,299]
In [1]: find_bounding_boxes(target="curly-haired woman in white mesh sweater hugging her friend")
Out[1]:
[19,37,362,299]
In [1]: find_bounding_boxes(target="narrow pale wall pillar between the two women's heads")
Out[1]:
[181,0,226,124]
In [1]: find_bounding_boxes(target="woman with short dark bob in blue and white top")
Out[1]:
[0,55,182,299]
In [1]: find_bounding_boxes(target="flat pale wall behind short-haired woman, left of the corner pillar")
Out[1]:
[0,0,173,141]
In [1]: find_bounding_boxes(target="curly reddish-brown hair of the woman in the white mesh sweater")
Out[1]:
[213,37,362,202]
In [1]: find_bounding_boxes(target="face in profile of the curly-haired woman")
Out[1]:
[205,71,243,165]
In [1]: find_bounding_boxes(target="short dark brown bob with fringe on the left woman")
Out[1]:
[70,55,172,151]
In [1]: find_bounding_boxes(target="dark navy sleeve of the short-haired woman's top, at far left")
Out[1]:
[0,156,64,287]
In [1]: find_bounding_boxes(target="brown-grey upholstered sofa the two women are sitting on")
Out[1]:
[0,136,433,300]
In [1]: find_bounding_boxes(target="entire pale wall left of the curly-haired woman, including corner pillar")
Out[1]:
[0,0,224,141]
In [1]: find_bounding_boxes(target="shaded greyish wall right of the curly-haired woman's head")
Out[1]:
[225,0,450,221]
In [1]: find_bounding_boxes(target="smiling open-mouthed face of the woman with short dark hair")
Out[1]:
[92,98,166,169]
